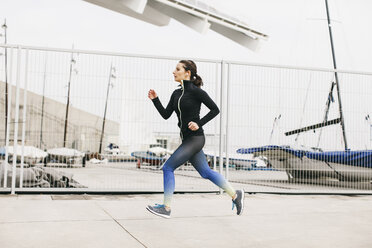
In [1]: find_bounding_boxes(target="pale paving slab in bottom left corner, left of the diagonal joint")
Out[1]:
[0,220,143,248]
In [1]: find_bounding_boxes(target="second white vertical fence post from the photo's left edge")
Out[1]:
[11,46,21,195]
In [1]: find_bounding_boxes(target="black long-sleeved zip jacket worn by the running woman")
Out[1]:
[152,80,220,140]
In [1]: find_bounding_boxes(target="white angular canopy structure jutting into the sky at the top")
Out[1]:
[84,0,268,50]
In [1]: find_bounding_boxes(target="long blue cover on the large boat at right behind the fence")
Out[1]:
[236,145,372,168]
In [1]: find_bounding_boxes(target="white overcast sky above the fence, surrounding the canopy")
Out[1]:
[0,0,372,71]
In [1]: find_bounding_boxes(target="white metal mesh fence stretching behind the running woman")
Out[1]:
[0,45,372,193]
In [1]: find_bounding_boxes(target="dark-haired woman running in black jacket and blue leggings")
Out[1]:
[146,60,244,218]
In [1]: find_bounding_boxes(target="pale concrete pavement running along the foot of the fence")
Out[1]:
[0,194,372,248]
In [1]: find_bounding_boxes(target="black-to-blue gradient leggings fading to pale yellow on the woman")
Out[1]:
[163,136,235,207]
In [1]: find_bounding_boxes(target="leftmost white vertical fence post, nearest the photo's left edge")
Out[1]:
[4,48,13,188]
